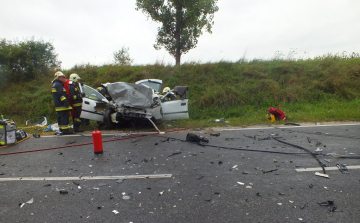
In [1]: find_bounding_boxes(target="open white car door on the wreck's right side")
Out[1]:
[161,86,189,120]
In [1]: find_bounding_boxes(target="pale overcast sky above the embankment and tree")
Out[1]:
[0,0,360,69]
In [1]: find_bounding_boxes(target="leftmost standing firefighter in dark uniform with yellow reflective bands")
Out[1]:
[52,71,72,135]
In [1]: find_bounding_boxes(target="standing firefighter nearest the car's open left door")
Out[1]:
[69,74,84,132]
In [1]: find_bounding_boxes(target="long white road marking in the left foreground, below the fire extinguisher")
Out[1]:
[0,174,172,182]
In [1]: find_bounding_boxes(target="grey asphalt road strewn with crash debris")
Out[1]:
[0,124,360,223]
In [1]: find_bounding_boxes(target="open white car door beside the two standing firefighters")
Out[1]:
[80,85,109,122]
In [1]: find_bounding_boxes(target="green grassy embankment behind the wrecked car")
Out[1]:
[0,55,360,131]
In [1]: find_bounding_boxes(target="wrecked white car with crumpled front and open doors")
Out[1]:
[80,79,189,127]
